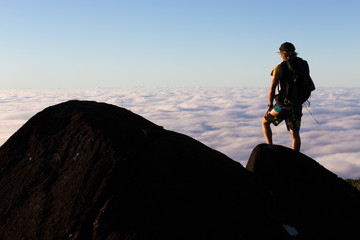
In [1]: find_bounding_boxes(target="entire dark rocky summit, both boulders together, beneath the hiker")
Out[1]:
[0,101,360,240]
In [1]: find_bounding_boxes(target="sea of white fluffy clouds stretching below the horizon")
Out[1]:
[0,88,360,178]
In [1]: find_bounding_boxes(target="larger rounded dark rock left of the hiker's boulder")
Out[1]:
[0,101,284,240]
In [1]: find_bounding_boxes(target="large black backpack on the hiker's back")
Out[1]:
[279,58,315,106]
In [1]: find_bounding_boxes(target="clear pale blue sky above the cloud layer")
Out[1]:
[0,0,360,88]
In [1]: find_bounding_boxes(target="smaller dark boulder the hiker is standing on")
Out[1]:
[246,144,360,240]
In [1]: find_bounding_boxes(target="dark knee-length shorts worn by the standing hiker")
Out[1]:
[264,105,302,132]
